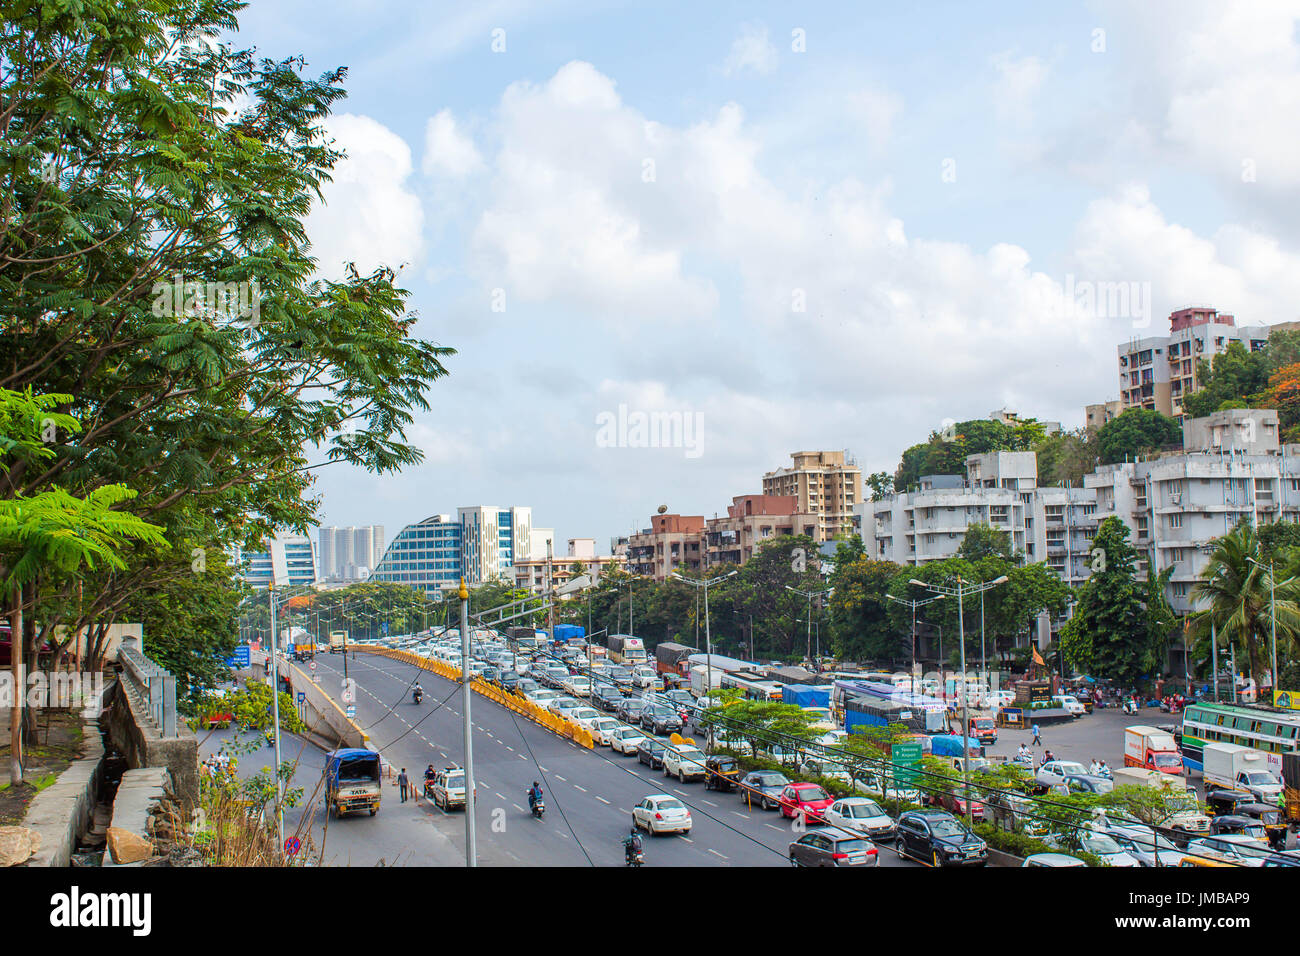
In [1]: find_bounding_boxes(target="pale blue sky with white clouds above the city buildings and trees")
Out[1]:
[238,0,1300,553]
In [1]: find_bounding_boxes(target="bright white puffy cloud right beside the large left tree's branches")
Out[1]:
[307,113,424,280]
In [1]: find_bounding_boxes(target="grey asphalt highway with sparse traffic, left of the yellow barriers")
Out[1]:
[296,653,915,866]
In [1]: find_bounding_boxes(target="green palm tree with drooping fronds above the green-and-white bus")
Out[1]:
[1192,520,1300,687]
